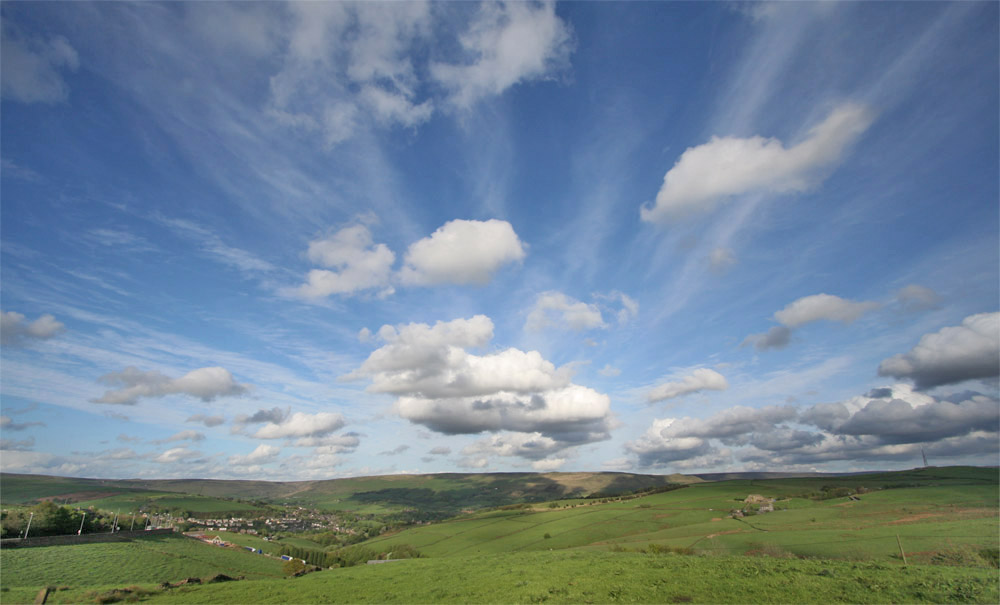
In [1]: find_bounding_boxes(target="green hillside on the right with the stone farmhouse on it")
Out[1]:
[360,469,1000,561]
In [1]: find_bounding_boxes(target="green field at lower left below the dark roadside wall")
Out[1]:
[0,535,283,588]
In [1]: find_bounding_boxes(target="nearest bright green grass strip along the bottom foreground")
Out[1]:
[29,551,1000,603]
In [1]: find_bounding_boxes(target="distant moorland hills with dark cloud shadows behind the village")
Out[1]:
[0,473,700,517]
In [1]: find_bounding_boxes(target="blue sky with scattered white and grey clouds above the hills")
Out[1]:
[0,2,1000,480]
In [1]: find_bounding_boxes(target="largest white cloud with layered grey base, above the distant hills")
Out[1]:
[347,315,610,447]
